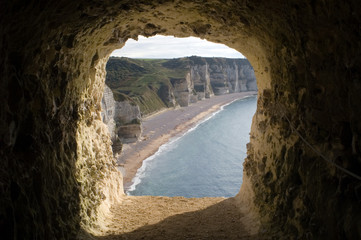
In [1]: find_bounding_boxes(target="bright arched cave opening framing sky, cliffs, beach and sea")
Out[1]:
[102,35,257,197]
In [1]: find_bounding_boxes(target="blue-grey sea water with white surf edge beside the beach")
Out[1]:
[127,97,257,197]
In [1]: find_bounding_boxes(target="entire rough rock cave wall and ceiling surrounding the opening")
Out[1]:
[0,0,361,239]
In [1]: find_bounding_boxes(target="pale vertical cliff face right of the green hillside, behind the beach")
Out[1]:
[171,57,257,107]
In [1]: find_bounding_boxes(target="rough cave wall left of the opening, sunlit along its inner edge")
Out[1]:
[0,1,123,239]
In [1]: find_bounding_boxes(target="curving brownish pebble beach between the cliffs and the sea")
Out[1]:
[117,92,257,190]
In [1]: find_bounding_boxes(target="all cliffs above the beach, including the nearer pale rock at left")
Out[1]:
[102,56,257,153]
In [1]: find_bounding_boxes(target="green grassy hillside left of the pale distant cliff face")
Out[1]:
[106,57,188,115]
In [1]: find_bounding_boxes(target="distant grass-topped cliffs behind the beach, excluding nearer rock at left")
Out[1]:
[106,56,257,115]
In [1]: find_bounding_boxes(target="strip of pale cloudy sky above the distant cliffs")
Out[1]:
[111,35,245,58]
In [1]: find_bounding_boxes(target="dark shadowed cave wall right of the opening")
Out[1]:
[239,1,361,239]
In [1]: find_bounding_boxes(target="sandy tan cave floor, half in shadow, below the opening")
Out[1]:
[91,196,257,240]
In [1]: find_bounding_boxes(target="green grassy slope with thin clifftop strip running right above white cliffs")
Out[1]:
[106,56,249,114]
